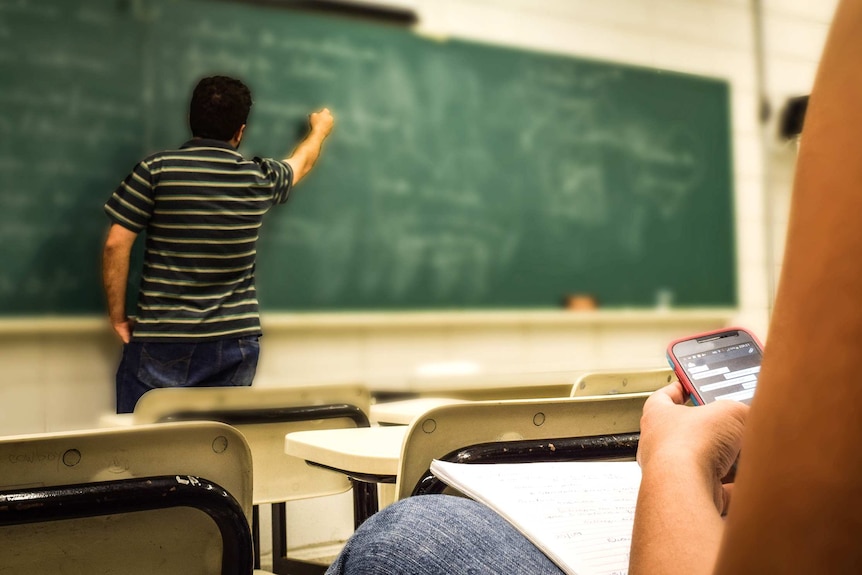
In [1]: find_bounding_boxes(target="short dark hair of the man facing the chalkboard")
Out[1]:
[189,76,251,142]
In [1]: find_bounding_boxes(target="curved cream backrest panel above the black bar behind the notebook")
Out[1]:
[395,393,649,499]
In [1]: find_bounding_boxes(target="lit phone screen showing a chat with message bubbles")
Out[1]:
[677,341,762,403]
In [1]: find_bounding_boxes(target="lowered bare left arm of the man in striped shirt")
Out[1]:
[102,224,138,343]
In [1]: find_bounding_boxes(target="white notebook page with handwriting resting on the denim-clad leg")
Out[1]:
[431,460,641,575]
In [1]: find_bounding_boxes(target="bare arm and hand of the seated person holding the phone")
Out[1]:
[631,0,862,575]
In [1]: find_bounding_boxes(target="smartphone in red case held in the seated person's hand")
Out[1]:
[667,327,763,405]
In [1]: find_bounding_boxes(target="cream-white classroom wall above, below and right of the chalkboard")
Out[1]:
[0,0,835,434]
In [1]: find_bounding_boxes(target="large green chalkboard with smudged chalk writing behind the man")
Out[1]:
[0,0,736,314]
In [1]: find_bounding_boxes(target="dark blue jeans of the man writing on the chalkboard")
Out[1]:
[117,336,260,413]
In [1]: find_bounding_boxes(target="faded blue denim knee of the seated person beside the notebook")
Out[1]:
[326,495,562,575]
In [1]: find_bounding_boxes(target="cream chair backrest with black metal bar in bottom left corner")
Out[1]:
[0,422,252,575]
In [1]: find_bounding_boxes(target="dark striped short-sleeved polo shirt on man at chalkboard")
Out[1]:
[105,139,293,342]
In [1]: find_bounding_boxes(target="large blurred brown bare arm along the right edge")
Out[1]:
[717,0,862,574]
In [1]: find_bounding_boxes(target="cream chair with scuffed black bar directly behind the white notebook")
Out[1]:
[395,393,650,499]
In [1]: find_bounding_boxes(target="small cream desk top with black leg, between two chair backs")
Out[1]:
[284,425,408,527]
